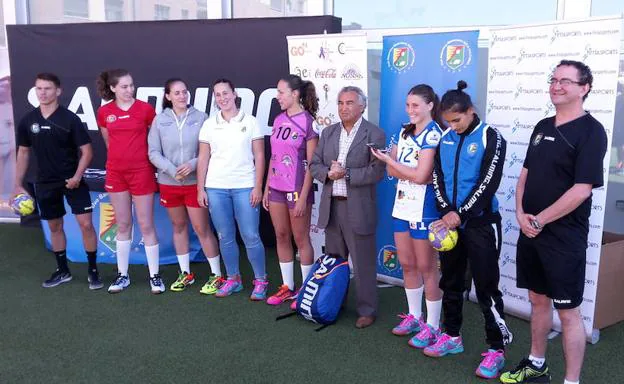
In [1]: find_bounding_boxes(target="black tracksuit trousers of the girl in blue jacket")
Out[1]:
[440,223,512,349]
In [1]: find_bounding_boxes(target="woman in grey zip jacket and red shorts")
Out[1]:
[148,78,223,294]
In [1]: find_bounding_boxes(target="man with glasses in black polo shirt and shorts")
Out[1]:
[501,60,607,384]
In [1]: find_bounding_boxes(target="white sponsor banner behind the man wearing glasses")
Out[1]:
[486,18,622,337]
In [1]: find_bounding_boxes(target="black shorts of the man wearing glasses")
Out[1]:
[516,234,587,309]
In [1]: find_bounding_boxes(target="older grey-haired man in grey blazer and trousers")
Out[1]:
[310,87,386,328]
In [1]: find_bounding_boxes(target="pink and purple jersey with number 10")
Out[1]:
[269,111,318,192]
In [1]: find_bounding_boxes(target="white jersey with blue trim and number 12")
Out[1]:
[392,121,442,223]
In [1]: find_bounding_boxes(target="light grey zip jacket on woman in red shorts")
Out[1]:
[147,106,208,185]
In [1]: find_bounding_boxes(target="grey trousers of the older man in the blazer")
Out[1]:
[325,198,378,316]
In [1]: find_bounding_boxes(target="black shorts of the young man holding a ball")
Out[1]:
[35,180,93,220]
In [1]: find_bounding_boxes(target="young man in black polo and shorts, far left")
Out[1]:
[15,73,103,289]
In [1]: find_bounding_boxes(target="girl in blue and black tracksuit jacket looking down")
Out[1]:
[424,81,512,378]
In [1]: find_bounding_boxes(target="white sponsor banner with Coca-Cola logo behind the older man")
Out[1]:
[288,34,368,258]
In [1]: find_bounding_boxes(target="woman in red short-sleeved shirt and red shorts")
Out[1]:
[96,69,165,294]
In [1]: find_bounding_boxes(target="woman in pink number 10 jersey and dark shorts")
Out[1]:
[262,75,318,305]
